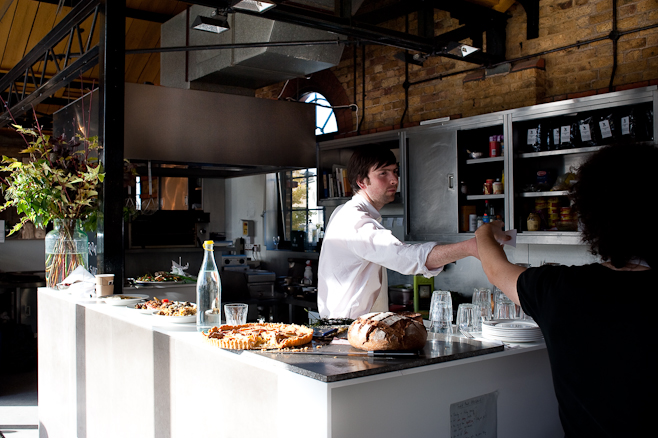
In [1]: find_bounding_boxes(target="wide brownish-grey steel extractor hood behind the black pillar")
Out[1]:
[53,83,316,178]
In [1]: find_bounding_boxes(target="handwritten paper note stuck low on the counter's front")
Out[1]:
[450,391,498,438]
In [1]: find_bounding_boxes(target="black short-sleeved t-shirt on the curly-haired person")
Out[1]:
[517,264,658,438]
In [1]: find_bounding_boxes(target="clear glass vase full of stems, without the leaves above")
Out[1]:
[45,219,89,288]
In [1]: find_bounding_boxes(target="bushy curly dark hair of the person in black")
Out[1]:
[570,144,658,268]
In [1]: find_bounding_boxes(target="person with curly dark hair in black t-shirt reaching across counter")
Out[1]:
[475,145,658,438]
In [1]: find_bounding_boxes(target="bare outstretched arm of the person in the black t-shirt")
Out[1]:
[475,221,526,304]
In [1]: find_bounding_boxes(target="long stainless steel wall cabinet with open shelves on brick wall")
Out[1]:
[318,86,658,245]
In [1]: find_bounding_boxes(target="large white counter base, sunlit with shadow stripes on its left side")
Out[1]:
[39,288,562,438]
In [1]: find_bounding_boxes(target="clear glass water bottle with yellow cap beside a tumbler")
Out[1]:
[196,240,222,331]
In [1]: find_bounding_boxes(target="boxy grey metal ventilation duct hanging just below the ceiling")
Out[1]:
[160,0,363,95]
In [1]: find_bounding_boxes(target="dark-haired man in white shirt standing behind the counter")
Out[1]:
[318,147,478,319]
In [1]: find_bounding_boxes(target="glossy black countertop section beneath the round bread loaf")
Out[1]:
[237,336,505,382]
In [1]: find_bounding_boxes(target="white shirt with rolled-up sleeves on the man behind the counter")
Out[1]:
[318,193,443,319]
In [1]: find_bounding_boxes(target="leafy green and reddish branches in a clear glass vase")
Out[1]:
[0,122,105,287]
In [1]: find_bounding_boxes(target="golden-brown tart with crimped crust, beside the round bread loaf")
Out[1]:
[203,323,313,350]
